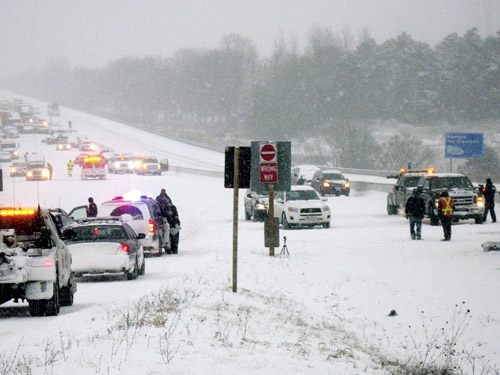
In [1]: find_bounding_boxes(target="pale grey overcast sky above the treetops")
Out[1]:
[0,0,500,74]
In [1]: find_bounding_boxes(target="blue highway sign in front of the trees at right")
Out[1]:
[445,133,484,172]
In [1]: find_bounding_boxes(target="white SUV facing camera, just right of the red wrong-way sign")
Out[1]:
[274,185,331,229]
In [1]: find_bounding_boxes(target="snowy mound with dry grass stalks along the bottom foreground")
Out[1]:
[0,277,499,375]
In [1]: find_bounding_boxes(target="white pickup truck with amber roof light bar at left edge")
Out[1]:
[0,208,76,316]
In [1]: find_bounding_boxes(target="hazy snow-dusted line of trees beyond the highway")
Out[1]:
[4,28,500,172]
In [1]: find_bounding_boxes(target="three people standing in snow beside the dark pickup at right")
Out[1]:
[405,178,497,241]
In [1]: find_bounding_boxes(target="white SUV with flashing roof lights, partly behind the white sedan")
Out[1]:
[69,196,170,256]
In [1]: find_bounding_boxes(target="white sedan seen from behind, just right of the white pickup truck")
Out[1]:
[63,217,146,280]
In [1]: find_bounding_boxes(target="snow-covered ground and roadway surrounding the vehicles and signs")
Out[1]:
[0,93,500,374]
